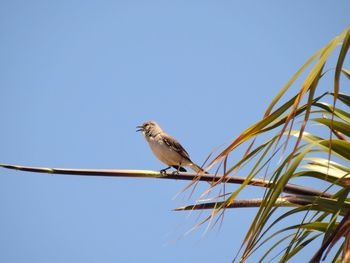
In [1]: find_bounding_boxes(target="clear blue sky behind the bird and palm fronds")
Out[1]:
[0,0,350,263]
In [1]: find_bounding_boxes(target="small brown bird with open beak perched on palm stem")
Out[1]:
[136,121,207,173]
